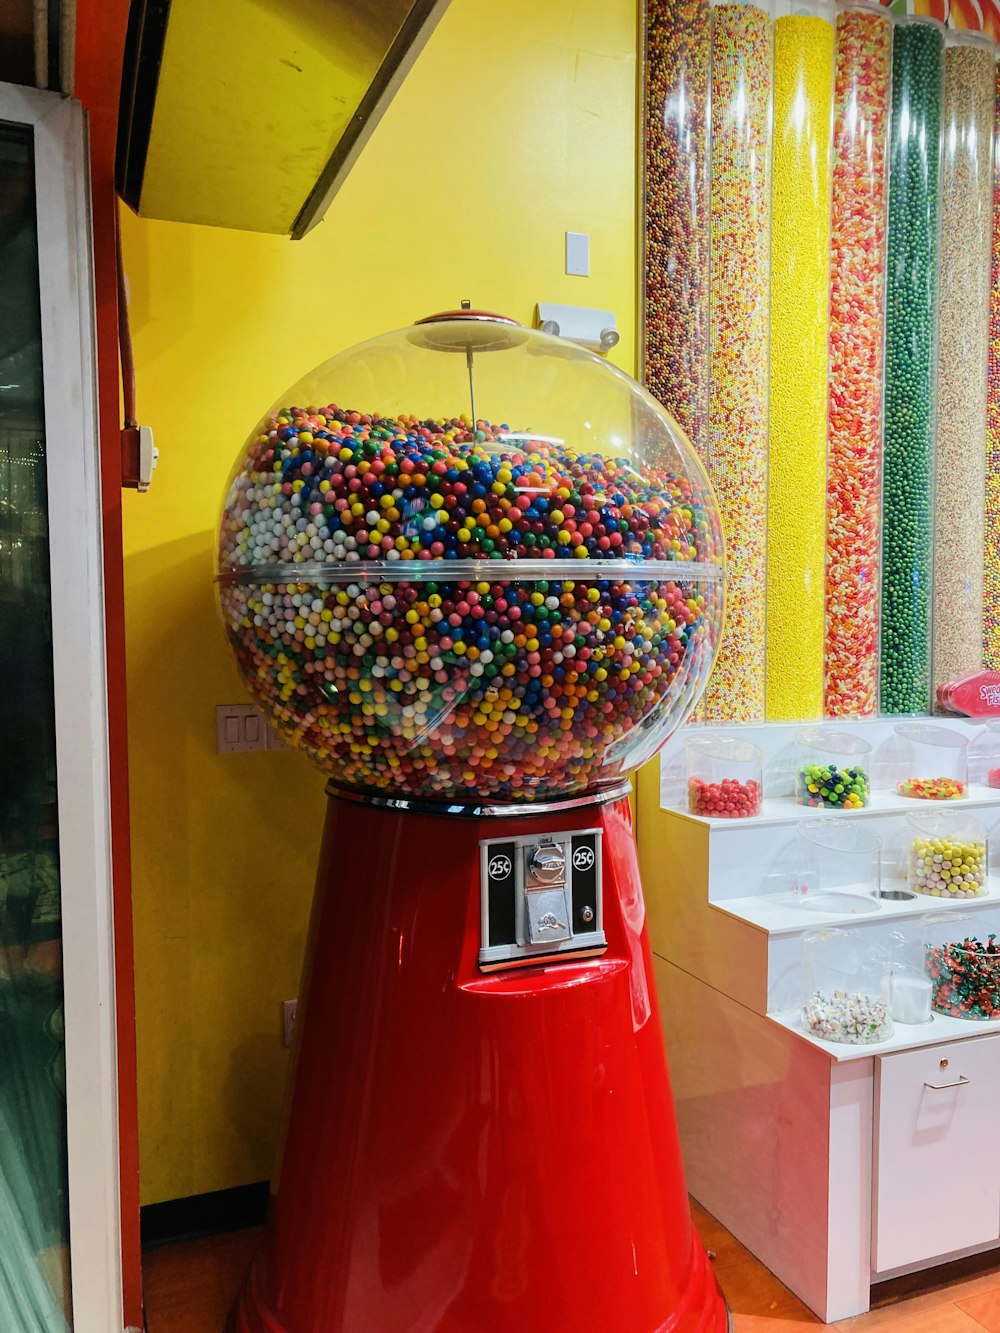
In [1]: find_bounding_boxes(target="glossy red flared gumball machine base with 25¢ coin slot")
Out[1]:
[229,796,728,1333]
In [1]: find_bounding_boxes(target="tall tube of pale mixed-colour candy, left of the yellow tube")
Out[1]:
[701,3,773,722]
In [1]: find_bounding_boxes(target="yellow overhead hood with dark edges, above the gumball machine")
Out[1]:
[117,0,448,240]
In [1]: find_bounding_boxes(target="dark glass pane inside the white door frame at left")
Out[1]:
[0,121,71,1333]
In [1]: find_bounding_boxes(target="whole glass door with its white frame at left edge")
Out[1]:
[0,85,123,1333]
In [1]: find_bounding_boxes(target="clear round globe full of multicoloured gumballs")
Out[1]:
[219,311,723,804]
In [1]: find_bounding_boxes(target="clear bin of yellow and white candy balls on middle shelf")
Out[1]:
[905,810,989,898]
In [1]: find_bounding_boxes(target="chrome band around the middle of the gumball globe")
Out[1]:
[216,560,723,585]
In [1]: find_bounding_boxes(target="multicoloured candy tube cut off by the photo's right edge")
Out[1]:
[983,65,1000,670]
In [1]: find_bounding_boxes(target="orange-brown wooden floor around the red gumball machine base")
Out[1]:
[144,1204,1000,1333]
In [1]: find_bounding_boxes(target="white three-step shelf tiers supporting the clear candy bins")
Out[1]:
[650,717,1000,1062]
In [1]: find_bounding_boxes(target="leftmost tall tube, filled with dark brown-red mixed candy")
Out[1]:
[640,0,711,460]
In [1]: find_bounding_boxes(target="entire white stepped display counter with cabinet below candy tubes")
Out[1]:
[637,718,1000,1322]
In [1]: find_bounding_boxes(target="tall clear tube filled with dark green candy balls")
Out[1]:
[880,17,944,713]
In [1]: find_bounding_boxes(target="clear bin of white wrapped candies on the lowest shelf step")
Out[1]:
[801,929,892,1046]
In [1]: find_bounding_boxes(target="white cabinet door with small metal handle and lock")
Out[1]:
[872,1034,1000,1273]
